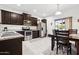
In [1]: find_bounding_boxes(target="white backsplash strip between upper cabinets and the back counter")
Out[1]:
[0,24,37,31]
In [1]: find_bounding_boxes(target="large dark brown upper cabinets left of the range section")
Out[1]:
[1,10,23,25]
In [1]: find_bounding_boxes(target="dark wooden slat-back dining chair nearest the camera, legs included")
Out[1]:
[55,30,71,55]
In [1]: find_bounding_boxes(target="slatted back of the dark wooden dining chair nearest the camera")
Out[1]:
[55,30,69,44]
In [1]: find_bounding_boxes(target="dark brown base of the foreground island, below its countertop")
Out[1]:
[0,37,24,55]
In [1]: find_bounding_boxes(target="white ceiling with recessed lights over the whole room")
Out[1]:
[0,4,79,18]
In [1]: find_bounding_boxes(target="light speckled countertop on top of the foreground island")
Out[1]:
[0,32,24,41]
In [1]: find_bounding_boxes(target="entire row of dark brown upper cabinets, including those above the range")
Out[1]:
[1,10,37,26]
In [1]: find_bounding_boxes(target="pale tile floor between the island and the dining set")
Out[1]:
[22,37,76,55]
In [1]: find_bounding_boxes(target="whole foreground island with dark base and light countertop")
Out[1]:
[0,32,24,55]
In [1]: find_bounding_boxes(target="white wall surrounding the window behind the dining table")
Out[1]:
[46,7,79,34]
